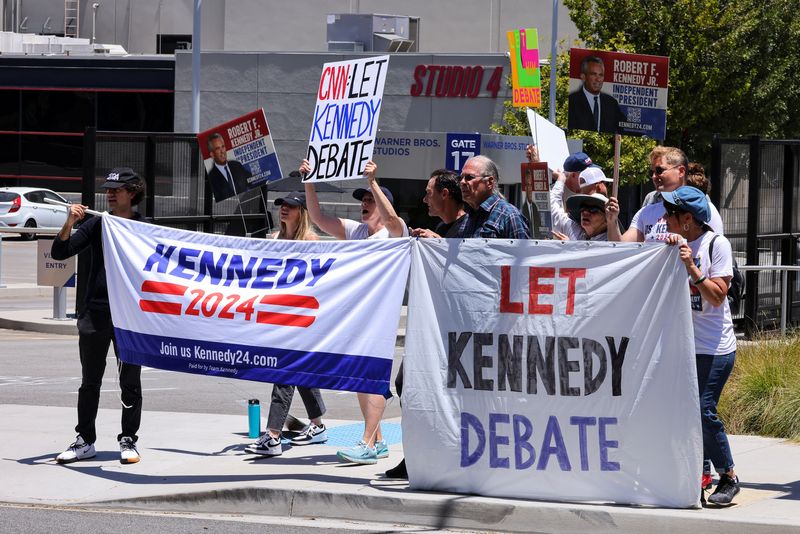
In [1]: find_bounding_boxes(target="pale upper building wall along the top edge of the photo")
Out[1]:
[10,0,577,55]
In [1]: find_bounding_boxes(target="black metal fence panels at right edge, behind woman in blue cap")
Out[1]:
[711,137,800,336]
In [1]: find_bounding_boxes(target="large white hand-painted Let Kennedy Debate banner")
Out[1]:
[402,239,703,507]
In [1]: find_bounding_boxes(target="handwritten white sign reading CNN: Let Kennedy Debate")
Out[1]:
[303,56,389,182]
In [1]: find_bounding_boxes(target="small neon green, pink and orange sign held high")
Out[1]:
[507,28,542,108]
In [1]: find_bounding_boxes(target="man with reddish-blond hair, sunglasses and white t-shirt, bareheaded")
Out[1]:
[609,146,723,242]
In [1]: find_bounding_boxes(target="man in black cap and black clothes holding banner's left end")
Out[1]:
[51,167,145,464]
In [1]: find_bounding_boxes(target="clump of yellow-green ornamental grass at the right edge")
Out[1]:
[719,336,800,441]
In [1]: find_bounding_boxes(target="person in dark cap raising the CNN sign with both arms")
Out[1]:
[300,160,408,464]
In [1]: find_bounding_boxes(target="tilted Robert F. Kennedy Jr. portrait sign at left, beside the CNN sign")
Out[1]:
[197,109,283,202]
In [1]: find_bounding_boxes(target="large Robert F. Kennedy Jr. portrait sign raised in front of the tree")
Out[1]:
[567,48,669,139]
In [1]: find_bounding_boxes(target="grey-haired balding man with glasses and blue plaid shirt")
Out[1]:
[457,156,531,239]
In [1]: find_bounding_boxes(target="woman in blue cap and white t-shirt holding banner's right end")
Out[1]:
[662,186,739,504]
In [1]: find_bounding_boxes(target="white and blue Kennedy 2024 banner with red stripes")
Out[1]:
[103,216,410,393]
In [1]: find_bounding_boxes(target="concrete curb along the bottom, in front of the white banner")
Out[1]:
[87,483,797,534]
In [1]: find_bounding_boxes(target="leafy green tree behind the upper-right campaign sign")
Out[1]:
[564,0,800,162]
